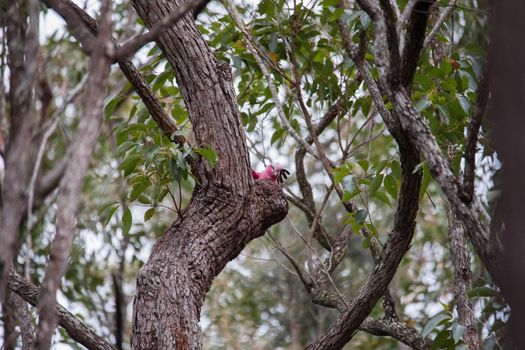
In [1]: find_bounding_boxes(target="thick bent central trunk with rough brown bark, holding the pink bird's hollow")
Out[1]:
[131,0,288,349]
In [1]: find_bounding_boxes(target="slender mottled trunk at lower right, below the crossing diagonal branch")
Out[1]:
[448,208,480,350]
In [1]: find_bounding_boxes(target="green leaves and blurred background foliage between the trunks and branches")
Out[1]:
[2,0,508,349]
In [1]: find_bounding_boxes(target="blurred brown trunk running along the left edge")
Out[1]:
[0,1,38,300]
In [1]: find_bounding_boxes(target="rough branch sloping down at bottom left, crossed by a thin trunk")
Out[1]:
[9,272,117,350]
